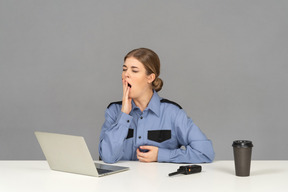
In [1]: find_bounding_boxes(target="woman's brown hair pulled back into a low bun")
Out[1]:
[124,48,163,92]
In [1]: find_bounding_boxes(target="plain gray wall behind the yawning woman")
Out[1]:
[0,0,288,160]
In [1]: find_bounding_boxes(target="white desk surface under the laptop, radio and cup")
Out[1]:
[0,161,288,192]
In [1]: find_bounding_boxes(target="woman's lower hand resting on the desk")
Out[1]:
[137,145,158,163]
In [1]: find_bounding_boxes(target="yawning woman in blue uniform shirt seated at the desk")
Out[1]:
[99,48,214,163]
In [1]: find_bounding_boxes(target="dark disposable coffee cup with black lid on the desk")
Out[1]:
[232,140,253,177]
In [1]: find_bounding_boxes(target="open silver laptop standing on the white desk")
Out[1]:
[35,131,129,177]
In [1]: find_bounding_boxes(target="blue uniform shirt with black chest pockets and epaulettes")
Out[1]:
[99,91,214,163]
